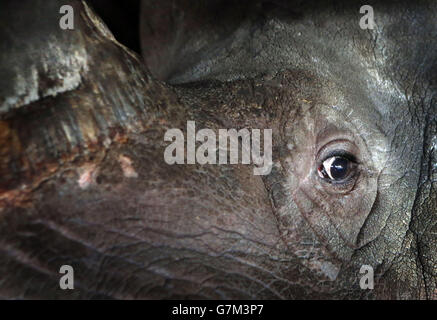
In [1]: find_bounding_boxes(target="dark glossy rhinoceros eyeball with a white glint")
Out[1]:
[317,154,356,183]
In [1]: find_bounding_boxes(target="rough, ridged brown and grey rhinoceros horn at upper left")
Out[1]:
[0,0,175,202]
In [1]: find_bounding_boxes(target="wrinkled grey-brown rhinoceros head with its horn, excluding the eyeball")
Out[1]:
[0,0,437,299]
